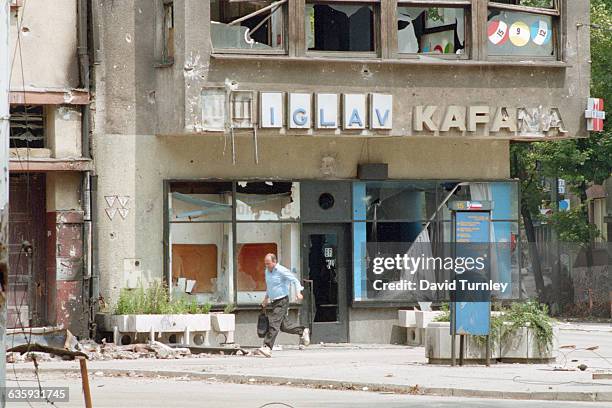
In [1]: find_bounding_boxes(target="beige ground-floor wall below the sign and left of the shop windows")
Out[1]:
[95,134,509,308]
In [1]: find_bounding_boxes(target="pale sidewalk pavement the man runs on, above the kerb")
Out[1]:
[7,323,612,402]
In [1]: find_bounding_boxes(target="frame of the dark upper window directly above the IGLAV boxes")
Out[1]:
[296,0,388,59]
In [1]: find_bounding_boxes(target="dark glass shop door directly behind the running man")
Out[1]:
[302,224,351,343]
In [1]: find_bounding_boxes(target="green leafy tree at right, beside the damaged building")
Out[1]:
[510,0,612,302]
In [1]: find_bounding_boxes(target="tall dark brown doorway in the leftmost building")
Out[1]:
[7,173,46,328]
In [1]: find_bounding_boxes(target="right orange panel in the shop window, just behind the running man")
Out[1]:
[237,242,277,291]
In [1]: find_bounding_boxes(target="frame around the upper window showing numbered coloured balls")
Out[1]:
[482,0,564,62]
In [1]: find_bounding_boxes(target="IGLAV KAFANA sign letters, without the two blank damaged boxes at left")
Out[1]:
[259,92,567,137]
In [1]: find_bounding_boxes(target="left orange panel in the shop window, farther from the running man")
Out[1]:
[172,244,217,293]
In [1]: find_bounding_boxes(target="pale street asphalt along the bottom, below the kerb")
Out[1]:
[8,374,609,408]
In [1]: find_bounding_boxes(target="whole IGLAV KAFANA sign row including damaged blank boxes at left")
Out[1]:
[202,91,567,138]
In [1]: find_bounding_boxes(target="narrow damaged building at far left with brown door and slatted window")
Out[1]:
[8,0,93,336]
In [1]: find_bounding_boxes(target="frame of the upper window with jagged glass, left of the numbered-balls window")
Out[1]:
[389,0,475,60]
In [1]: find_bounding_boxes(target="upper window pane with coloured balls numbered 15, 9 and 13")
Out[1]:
[487,0,559,57]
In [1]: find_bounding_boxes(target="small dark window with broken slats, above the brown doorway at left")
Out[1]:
[10,105,45,149]
